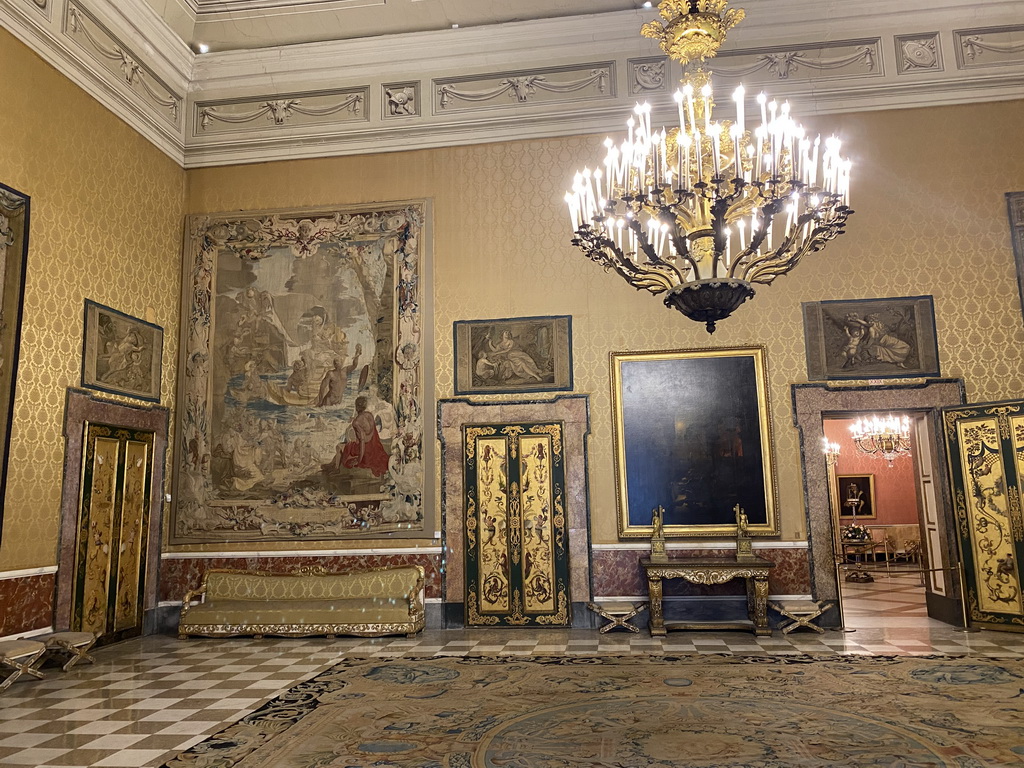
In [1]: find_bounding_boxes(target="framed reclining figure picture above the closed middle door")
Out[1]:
[455,314,572,394]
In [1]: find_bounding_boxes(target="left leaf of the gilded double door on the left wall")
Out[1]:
[74,437,121,635]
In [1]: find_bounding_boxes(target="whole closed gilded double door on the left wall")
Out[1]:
[72,424,154,642]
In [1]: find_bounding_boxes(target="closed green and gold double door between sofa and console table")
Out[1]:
[463,422,571,627]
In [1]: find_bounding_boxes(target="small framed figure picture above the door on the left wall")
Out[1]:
[82,299,164,402]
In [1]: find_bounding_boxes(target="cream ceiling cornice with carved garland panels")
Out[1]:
[0,0,1024,167]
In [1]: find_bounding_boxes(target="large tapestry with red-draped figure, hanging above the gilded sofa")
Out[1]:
[171,203,432,543]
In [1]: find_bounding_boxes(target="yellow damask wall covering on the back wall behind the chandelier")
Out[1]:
[186,101,1024,543]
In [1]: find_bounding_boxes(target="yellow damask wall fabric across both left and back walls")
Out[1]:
[0,18,1024,568]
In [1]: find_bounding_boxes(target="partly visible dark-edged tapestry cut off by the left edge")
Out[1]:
[0,184,31,541]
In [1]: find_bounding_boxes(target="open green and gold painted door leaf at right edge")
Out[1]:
[943,401,1024,632]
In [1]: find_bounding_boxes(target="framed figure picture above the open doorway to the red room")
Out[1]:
[803,296,939,381]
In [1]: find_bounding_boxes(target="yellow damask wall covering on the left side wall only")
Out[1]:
[0,30,184,570]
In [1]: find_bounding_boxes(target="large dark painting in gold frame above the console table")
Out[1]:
[611,347,778,538]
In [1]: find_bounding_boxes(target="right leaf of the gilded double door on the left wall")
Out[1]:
[114,440,150,632]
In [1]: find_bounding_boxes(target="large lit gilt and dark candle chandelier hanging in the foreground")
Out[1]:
[565,0,853,333]
